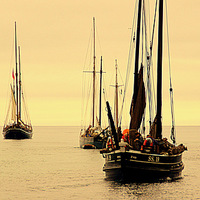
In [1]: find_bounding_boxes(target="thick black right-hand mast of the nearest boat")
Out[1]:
[156,0,163,139]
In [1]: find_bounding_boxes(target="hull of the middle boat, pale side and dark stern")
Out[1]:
[80,137,106,149]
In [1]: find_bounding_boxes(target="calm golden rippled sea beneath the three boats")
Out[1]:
[0,127,200,200]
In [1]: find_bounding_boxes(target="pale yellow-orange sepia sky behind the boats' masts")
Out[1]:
[0,0,200,126]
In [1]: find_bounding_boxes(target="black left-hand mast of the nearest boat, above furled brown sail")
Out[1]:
[134,0,142,107]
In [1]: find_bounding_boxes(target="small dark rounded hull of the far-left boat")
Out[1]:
[3,128,33,140]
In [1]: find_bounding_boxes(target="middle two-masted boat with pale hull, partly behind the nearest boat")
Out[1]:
[80,18,108,149]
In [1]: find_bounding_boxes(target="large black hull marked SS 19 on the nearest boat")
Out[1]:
[103,150,184,181]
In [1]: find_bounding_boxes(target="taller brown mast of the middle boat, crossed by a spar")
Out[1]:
[92,17,96,127]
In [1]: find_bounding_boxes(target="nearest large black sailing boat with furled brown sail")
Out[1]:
[100,0,187,181]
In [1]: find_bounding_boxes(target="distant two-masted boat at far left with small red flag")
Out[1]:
[3,22,33,139]
